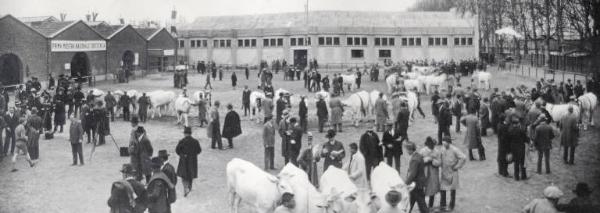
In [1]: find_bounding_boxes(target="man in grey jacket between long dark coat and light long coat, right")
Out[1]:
[533,113,555,174]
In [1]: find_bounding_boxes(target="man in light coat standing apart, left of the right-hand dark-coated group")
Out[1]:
[460,111,485,160]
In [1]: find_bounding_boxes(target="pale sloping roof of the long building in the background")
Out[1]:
[178,11,474,30]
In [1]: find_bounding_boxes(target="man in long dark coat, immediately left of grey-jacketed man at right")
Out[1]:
[506,117,529,181]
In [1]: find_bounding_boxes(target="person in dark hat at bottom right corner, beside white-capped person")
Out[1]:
[557,182,600,213]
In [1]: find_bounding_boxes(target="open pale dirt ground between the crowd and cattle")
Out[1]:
[0,67,600,213]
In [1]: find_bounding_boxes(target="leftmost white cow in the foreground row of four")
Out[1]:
[226,158,293,213]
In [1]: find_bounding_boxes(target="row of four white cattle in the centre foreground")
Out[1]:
[227,158,414,213]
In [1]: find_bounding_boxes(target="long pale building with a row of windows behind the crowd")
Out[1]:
[178,11,479,65]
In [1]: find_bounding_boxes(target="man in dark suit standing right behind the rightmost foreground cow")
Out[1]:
[381,123,402,172]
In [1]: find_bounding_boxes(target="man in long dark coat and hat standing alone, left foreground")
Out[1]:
[175,127,202,196]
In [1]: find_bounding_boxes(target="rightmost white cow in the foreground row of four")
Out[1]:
[371,162,414,212]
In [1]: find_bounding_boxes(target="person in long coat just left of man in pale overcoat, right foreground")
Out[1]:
[419,137,443,208]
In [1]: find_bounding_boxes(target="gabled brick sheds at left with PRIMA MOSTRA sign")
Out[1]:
[0,15,177,86]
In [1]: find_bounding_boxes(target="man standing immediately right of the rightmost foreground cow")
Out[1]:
[404,142,429,213]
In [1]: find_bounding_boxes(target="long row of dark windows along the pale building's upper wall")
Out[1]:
[179,36,473,48]
